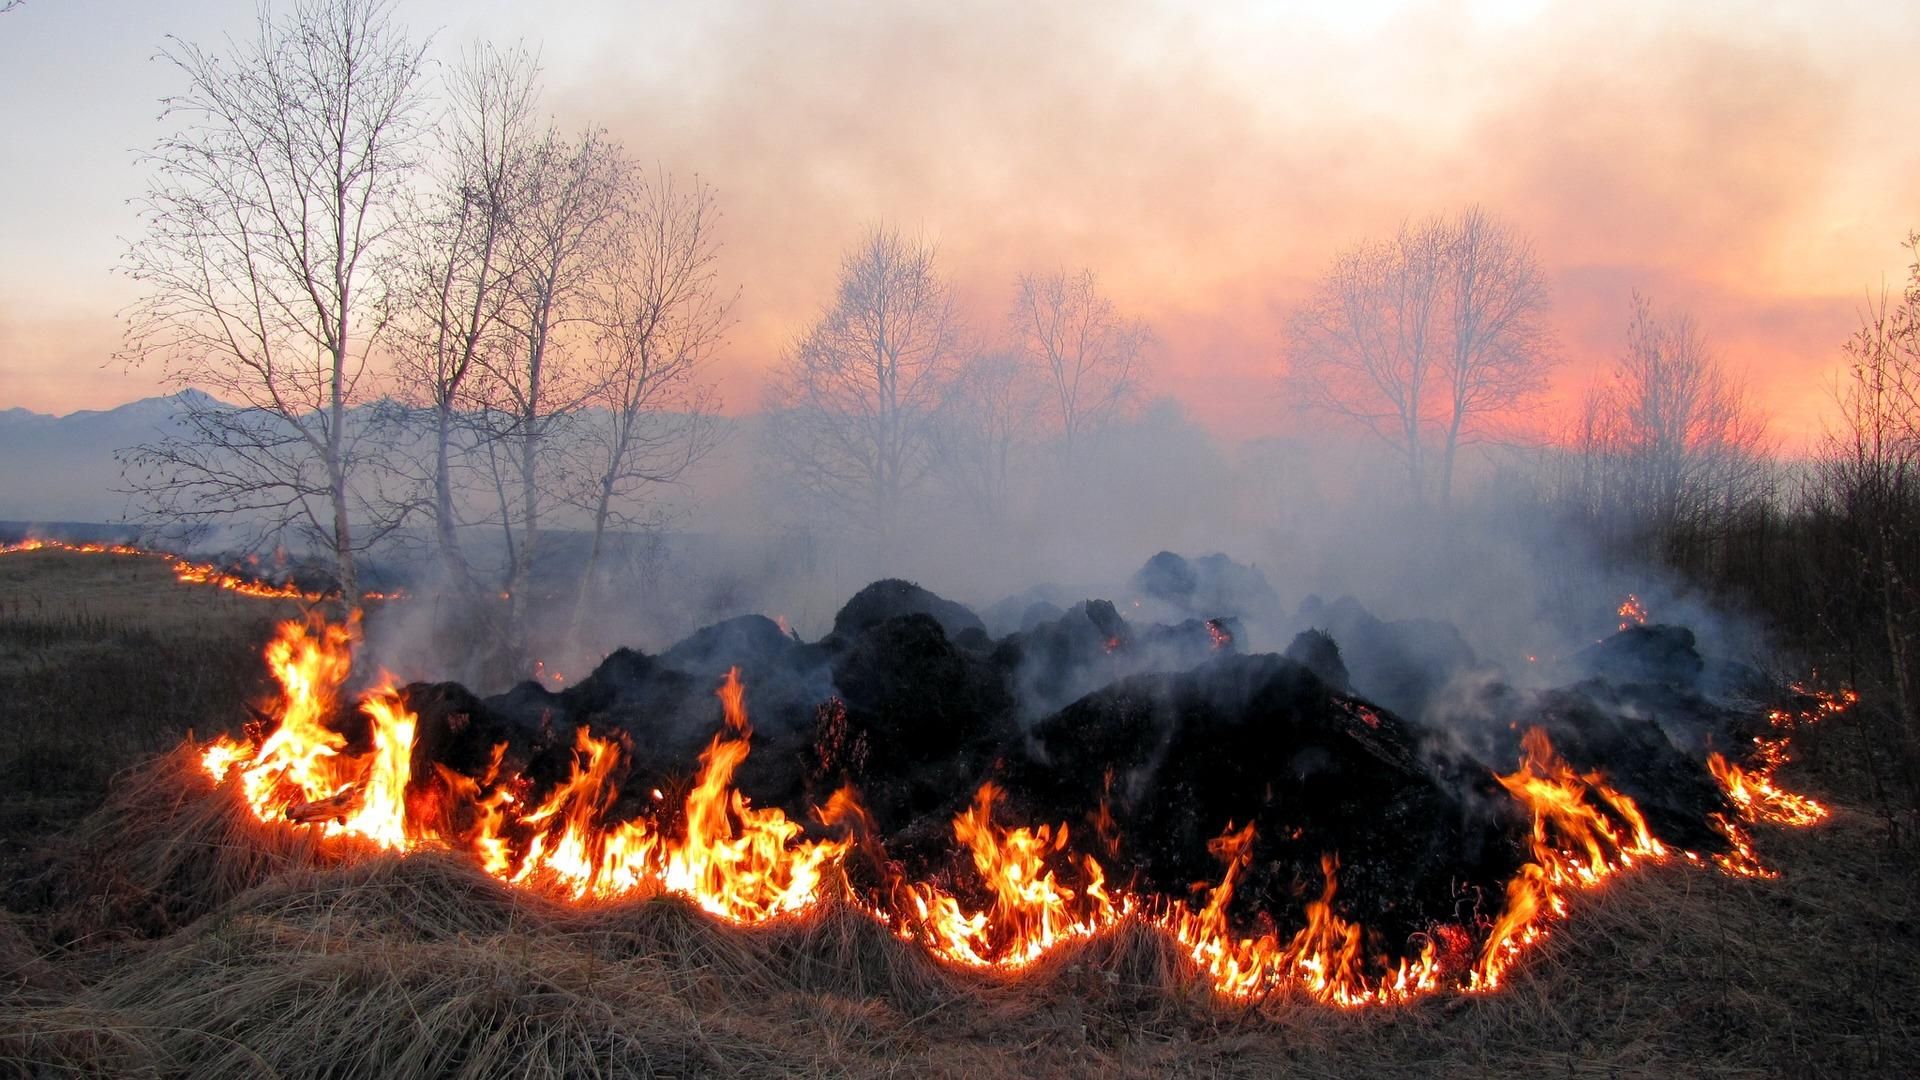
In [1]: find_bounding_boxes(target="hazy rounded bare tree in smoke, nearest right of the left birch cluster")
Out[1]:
[766,227,964,553]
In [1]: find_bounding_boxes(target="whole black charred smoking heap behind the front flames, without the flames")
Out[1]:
[362,553,1764,951]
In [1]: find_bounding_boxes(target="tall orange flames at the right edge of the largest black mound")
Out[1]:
[1469,728,1667,990]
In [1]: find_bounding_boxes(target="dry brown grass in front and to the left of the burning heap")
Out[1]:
[0,555,1920,1076]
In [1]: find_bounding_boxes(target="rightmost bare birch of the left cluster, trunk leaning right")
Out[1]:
[568,173,733,636]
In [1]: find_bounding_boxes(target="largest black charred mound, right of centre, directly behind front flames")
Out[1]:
[996,655,1521,940]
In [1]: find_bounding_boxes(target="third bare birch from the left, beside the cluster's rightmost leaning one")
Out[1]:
[480,131,632,645]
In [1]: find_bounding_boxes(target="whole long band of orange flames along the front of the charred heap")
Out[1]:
[200,617,1824,1007]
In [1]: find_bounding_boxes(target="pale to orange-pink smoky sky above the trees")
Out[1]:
[0,0,1920,452]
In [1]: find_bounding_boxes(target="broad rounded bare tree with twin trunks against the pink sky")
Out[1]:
[1286,208,1553,503]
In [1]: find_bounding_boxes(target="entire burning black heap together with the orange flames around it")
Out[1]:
[86,546,1827,1007]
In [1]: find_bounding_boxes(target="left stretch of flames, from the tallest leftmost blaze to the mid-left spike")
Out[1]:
[202,621,847,922]
